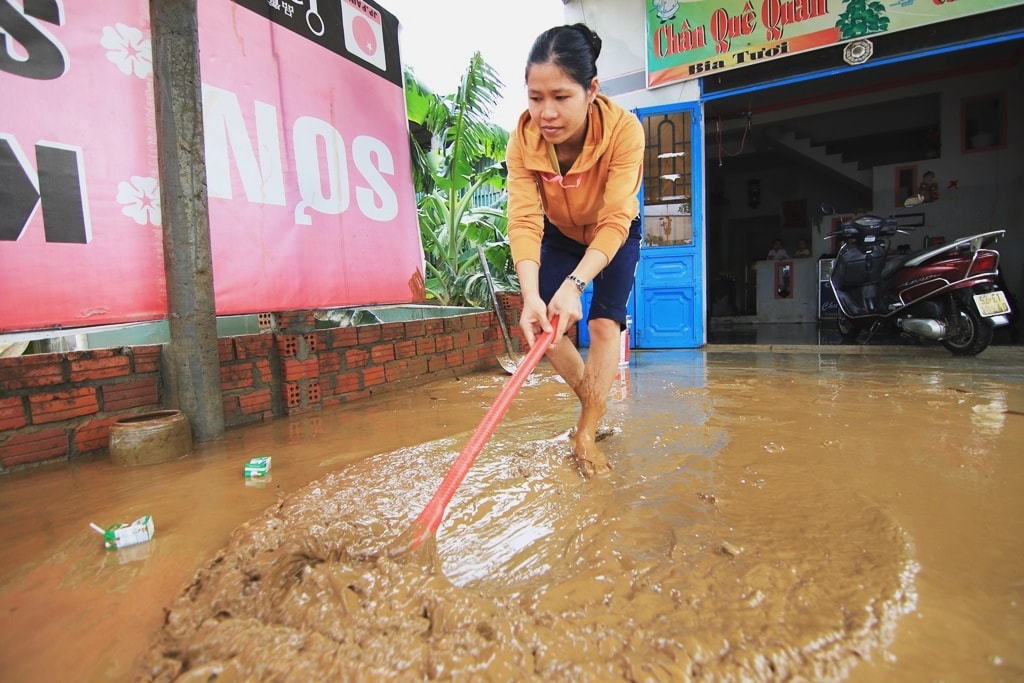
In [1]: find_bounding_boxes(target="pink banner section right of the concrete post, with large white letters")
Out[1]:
[199,0,423,313]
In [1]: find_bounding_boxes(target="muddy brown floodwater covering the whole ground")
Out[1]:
[0,347,1024,682]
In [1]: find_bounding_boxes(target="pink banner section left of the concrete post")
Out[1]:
[0,0,167,332]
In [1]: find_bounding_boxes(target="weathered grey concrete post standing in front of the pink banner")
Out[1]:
[150,0,224,441]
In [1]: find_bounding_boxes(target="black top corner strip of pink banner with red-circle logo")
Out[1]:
[232,0,402,86]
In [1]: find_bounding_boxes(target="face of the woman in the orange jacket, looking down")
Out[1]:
[526,63,597,144]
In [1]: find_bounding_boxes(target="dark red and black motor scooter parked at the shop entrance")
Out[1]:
[821,195,1011,355]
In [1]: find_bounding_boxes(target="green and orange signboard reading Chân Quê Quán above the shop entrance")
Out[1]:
[646,0,1024,88]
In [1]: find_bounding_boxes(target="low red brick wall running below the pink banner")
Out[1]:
[0,305,548,474]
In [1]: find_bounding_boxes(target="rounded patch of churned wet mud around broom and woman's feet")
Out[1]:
[138,369,919,682]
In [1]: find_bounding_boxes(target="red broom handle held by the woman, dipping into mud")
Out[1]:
[399,315,558,552]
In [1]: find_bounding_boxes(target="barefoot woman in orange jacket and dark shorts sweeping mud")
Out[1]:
[507,24,644,476]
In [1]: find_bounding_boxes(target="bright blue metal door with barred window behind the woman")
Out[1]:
[631,103,705,348]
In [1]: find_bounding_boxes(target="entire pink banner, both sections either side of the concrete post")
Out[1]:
[0,0,423,332]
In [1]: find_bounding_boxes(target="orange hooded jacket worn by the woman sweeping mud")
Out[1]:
[506,94,644,263]
